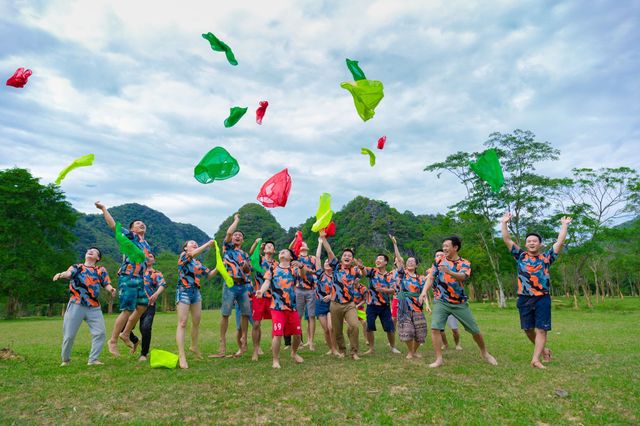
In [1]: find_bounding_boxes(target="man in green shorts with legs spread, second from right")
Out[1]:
[420,236,498,368]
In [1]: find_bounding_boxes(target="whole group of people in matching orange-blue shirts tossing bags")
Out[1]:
[53,201,571,368]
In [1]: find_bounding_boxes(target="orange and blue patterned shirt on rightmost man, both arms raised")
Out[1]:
[511,244,558,296]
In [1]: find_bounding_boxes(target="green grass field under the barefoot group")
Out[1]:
[0,298,640,425]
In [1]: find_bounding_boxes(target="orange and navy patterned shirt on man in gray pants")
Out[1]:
[69,263,111,308]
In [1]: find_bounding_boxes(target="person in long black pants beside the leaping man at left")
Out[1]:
[127,253,167,361]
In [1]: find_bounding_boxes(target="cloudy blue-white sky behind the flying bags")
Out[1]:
[0,0,640,235]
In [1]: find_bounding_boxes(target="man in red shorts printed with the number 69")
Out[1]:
[256,249,307,368]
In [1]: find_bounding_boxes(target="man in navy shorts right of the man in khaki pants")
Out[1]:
[358,253,400,355]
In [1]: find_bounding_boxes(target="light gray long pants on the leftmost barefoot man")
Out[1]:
[62,303,107,362]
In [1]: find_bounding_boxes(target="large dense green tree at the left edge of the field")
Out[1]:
[0,168,77,317]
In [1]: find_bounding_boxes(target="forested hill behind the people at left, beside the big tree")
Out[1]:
[74,203,209,259]
